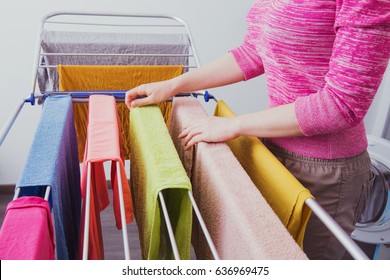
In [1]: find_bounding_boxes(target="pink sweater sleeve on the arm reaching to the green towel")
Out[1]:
[230,6,264,80]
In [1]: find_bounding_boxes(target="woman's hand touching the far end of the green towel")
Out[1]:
[125,80,176,109]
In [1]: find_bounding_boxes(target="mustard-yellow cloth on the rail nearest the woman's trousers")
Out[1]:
[214,100,313,247]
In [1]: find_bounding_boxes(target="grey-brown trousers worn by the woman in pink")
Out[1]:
[264,141,374,260]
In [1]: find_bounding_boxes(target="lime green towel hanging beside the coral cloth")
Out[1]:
[130,105,192,259]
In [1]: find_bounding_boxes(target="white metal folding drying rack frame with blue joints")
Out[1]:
[0,12,368,260]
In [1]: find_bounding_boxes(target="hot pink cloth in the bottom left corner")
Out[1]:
[0,196,55,260]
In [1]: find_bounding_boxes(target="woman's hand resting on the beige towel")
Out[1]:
[179,117,239,149]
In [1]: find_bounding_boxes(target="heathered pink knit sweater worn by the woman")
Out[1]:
[231,0,390,159]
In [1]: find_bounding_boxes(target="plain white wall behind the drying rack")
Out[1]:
[0,0,266,185]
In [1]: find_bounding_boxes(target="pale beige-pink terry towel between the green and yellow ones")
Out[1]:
[169,97,307,260]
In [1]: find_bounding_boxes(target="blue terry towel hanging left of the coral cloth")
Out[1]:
[16,96,81,260]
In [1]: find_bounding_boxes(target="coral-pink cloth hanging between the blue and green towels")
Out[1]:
[80,95,133,259]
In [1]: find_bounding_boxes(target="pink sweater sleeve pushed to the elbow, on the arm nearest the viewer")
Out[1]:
[295,0,390,136]
